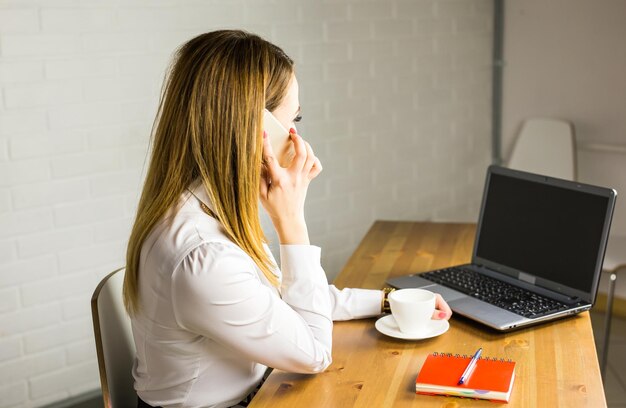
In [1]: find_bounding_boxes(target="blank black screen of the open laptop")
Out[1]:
[476,173,608,292]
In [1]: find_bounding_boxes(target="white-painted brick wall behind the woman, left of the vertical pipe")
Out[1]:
[0,0,492,407]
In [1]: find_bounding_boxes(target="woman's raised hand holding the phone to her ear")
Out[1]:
[260,128,322,245]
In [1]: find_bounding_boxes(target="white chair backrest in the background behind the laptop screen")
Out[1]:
[507,118,576,180]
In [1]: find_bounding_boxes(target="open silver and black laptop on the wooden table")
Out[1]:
[387,166,617,331]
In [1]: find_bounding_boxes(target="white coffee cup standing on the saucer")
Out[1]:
[389,289,435,335]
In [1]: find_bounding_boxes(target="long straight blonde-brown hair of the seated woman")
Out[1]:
[124,30,294,314]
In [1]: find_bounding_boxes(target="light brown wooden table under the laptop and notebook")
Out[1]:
[250,221,606,408]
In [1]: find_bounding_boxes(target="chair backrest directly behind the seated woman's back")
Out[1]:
[91,268,137,407]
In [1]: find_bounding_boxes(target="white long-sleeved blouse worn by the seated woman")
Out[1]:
[131,182,382,407]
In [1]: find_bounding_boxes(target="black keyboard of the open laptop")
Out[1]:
[419,267,568,319]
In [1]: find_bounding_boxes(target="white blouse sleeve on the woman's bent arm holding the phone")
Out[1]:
[171,242,333,373]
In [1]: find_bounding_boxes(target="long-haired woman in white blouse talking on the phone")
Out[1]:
[124,31,451,407]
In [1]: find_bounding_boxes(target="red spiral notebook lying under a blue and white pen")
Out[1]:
[415,353,515,402]
